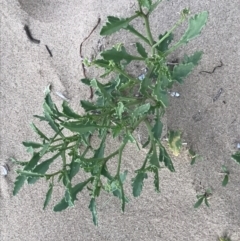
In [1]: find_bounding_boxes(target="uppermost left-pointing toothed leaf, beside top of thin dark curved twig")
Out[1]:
[100,16,136,36]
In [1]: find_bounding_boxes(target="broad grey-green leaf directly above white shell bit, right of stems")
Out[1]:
[172,63,194,83]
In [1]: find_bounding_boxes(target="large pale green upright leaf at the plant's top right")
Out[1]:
[179,11,208,44]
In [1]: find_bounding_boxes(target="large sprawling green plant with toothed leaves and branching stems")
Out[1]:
[13,0,208,224]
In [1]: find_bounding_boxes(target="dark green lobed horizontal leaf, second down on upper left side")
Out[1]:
[101,46,138,64]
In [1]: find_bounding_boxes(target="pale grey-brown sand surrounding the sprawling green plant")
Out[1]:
[0,0,240,241]
